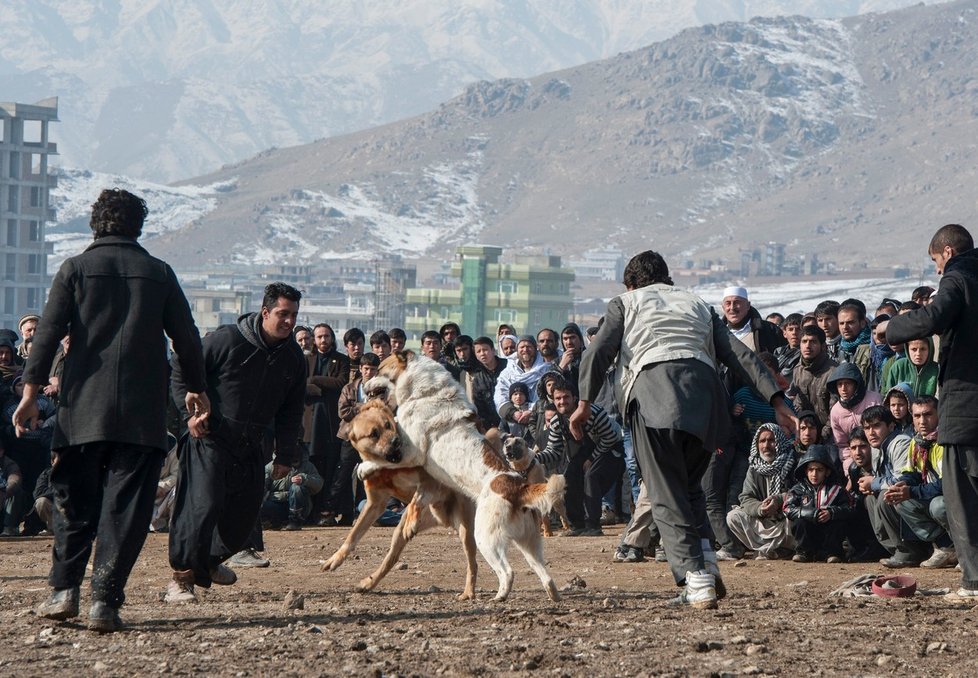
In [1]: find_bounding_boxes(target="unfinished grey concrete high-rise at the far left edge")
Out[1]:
[0,97,58,328]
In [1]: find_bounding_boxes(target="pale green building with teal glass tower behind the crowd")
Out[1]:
[404,245,574,340]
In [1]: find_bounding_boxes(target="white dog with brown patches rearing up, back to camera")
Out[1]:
[366,351,565,601]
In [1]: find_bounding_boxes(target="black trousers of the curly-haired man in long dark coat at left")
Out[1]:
[49,442,164,608]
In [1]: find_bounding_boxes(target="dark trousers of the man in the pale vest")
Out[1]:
[632,428,713,584]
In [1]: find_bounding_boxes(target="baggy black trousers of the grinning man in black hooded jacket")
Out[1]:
[170,436,265,588]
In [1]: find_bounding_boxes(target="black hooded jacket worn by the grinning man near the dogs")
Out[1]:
[172,313,306,465]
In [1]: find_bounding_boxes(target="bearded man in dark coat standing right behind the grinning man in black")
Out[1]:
[304,323,350,525]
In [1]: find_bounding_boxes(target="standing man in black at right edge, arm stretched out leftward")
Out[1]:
[876,224,978,598]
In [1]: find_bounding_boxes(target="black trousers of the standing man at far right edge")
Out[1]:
[942,445,978,589]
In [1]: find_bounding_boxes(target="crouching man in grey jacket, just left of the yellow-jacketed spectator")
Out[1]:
[858,405,929,568]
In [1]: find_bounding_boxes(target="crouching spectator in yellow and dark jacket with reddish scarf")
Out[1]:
[886,396,958,568]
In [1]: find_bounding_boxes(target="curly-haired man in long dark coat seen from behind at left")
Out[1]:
[13,189,210,632]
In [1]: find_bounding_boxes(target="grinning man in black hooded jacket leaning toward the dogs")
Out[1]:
[166,283,306,602]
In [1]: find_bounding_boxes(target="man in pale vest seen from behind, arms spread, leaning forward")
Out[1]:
[569,250,796,609]
